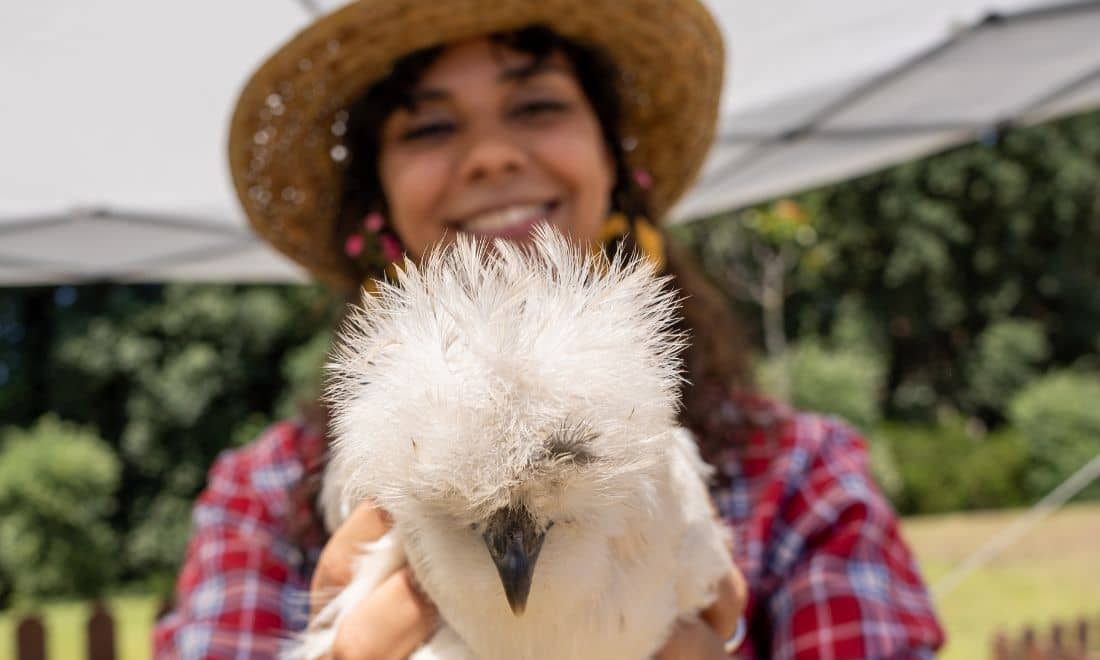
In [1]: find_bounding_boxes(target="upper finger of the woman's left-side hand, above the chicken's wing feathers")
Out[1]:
[309,503,391,616]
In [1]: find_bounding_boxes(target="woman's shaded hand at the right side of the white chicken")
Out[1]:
[656,569,748,660]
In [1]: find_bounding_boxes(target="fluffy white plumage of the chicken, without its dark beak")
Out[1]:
[305,230,729,660]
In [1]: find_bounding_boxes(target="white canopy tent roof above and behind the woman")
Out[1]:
[0,0,1100,285]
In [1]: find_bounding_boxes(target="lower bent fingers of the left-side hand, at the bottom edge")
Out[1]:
[332,568,439,660]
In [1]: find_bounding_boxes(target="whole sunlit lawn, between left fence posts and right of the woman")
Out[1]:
[0,504,1100,660]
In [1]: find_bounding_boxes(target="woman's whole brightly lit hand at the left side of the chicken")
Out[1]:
[310,504,438,660]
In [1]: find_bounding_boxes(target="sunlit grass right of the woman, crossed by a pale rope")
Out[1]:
[902,504,1100,660]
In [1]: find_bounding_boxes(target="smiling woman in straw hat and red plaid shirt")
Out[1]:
[155,0,943,658]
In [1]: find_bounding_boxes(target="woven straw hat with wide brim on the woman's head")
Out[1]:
[229,0,725,288]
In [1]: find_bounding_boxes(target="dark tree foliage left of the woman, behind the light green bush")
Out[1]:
[0,285,340,576]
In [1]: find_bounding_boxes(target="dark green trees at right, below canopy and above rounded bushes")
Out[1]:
[802,113,1100,416]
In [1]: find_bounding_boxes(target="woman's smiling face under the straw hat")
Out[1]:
[380,39,615,259]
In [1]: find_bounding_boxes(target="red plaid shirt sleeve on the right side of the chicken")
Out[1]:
[767,420,944,660]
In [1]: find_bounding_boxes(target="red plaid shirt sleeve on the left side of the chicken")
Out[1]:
[153,425,308,660]
